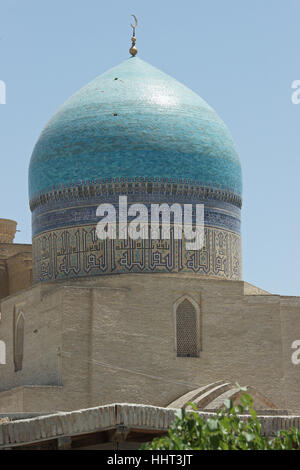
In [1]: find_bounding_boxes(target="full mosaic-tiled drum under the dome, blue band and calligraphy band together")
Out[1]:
[32,184,241,282]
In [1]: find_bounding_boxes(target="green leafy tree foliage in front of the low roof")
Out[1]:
[142,388,300,450]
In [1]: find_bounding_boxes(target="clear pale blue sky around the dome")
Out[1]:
[0,0,300,295]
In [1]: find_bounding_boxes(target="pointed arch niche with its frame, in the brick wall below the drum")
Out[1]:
[173,295,201,357]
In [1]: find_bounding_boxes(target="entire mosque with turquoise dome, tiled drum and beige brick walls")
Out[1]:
[0,23,300,448]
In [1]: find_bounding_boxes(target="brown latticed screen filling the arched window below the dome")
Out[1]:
[176,300,198,357]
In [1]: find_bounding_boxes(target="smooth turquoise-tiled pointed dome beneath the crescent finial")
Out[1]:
[29,57,242,200]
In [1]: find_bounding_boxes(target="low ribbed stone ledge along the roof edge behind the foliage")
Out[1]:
[0,403,300,449]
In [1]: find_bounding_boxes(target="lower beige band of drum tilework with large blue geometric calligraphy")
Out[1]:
[33,225,241,282]
